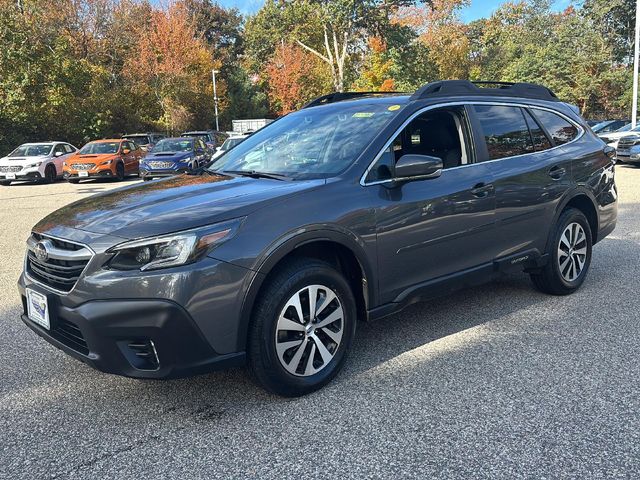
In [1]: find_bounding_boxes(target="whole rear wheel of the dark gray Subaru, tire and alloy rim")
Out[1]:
[531,208,593,295]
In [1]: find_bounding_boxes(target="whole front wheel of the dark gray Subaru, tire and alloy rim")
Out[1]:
[248,258,356,397]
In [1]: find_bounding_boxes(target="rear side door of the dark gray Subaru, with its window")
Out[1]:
[473,104,578,257]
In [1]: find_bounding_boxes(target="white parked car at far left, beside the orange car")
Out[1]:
[0,142,78,186]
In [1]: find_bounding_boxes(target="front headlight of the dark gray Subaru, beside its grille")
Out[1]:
[107,217,244,271]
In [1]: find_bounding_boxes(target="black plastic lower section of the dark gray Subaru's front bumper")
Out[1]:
[22,290,244,378]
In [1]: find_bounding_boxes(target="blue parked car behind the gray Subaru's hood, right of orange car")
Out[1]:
[140,137,210,180]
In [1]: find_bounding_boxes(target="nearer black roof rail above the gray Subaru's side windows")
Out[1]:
[410,80,559,101]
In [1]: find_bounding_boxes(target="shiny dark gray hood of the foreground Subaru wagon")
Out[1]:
[34,173,324,239]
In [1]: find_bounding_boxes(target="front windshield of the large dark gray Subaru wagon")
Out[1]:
[211,101,399,179]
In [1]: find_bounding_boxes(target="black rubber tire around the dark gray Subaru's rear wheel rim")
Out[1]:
[531,208,593,295]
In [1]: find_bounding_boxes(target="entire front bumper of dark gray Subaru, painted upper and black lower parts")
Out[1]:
[18,226,256,378]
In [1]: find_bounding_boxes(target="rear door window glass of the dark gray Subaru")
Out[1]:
[474,105,533,160]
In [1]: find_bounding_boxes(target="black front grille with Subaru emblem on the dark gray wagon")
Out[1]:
[26,234,92,293]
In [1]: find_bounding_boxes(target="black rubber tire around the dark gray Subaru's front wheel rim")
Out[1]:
[247,258,357,397]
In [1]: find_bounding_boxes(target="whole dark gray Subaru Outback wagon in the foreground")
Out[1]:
[19,81,617,395]
